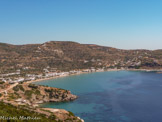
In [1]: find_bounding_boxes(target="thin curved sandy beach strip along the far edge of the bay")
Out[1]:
[25,69,162,84]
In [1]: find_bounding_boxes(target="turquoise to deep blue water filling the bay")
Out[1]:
[34,71,162,122]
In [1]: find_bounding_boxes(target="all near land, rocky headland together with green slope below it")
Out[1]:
[0,83,83,122]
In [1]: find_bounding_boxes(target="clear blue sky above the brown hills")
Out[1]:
[0,0,162,49]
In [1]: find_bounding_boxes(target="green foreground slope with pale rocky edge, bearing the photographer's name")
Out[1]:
[0,102,84,122]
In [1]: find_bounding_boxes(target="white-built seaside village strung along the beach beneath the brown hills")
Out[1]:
[0,67,105,84]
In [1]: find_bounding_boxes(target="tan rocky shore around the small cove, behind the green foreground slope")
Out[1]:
[0,83,84,122]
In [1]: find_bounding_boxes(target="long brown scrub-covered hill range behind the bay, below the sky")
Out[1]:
[0,41,162,72]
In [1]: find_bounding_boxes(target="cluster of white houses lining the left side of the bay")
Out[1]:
[0,67,104,83]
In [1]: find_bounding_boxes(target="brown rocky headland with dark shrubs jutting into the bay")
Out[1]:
[4,83,77,106]
